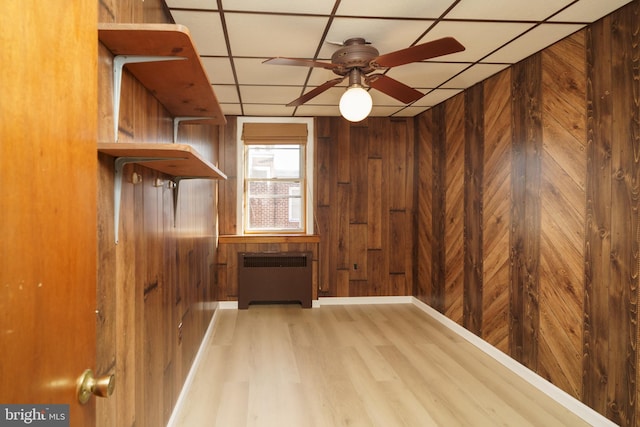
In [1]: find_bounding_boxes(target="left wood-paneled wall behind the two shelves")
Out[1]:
[97,0,219,427]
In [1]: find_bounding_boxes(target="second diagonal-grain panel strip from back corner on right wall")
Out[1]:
[444,94,464,324]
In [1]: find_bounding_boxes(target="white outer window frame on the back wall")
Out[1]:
[236,117,315,235]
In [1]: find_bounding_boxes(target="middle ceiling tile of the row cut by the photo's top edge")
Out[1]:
[337,0,453,19]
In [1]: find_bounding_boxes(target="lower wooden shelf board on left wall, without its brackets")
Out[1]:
[98,142,227,179]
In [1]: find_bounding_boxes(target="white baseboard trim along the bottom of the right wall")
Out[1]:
[412,297,617,427]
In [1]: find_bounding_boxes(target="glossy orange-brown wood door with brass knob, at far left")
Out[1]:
[0,0,98,426]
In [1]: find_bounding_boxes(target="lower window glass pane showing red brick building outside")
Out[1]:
[247,181,303,231]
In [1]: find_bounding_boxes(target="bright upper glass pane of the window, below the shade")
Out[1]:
[247,145,302,178]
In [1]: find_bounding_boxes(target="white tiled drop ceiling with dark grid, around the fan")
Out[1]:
[166,0,630,117]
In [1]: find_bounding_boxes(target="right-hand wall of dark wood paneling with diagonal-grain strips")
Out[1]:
[415,1,640,426]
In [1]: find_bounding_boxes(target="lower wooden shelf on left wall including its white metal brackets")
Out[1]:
[98,142,227,244]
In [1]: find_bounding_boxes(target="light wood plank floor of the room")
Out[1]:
[170,304,587,427]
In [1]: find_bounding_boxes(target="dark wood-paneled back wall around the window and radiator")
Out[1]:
[217,117,416,300]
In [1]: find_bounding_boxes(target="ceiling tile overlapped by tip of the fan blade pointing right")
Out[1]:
[421,21,534,62]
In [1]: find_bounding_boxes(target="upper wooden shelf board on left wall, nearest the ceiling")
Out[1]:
[98,23,226,124]
